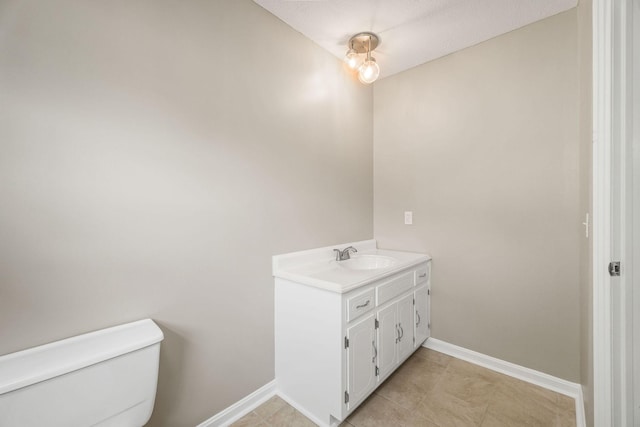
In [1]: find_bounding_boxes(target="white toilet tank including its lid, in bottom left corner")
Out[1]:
[0,319,164,427]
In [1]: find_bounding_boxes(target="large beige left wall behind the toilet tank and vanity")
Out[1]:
[0,0,373,427]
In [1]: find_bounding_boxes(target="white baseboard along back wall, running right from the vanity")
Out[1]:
[422,338,586,427]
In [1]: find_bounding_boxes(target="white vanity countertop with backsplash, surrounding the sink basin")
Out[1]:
[273,240,431,293]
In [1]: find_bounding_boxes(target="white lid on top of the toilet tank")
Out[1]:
[0,319,164,395]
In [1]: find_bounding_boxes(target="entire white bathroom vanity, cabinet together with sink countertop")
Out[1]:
[273,240,431,426]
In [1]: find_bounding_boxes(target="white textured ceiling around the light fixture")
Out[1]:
[254,0,578,78]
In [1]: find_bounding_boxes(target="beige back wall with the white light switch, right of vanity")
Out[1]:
[374,9,584,382]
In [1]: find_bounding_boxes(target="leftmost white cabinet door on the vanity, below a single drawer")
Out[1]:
[347,314,376,408]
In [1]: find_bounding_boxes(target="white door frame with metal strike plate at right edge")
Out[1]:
[592,0,640,427]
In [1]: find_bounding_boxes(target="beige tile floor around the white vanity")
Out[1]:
[233,348,576,427]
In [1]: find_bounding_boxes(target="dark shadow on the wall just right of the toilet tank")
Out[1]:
[147,320,187,427]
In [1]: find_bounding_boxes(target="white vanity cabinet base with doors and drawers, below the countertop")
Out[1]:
[275,256,430,426]
